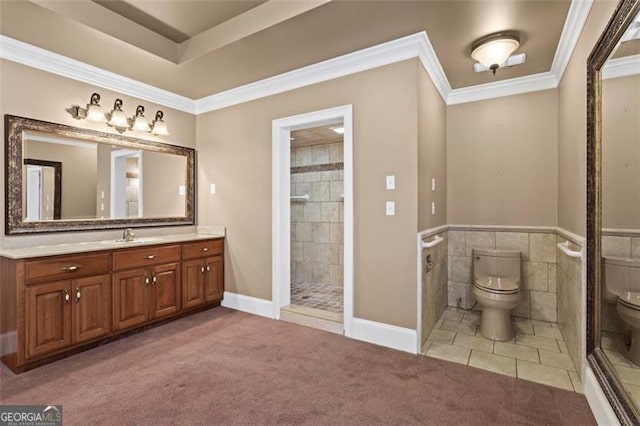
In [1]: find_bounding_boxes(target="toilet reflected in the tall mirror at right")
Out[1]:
[602,257,640,366]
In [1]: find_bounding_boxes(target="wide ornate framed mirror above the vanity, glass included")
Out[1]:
[5,115,195,235]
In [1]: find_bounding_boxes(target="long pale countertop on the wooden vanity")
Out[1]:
[0,232,224,259]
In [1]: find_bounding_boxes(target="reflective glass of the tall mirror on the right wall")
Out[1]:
[600,5,640,408]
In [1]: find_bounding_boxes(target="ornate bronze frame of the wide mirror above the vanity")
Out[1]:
[4,114,196,235]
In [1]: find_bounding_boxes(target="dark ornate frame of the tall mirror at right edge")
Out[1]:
[586,0,640,425]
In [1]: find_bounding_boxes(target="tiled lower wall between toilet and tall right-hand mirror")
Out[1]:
[556,235,583,375]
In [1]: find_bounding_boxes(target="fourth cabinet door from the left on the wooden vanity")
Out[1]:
[151,263,180,318]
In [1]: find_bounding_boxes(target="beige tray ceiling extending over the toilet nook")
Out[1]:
[0,0,616,99]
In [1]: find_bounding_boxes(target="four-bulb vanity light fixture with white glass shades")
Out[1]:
[66,93,169,136]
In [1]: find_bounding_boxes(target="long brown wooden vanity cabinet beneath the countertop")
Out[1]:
[0,238,224,373]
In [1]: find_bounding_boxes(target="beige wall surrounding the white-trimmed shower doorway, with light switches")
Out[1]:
[197,60,418,328]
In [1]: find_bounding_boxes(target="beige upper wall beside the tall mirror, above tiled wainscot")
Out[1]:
[558,0,617,236]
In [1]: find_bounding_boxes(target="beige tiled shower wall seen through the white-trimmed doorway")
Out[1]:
[291,143,344,287]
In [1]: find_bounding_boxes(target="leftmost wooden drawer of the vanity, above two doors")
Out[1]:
[25,253,111,284]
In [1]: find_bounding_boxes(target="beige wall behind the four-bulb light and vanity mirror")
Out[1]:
[0,60,195,246]
